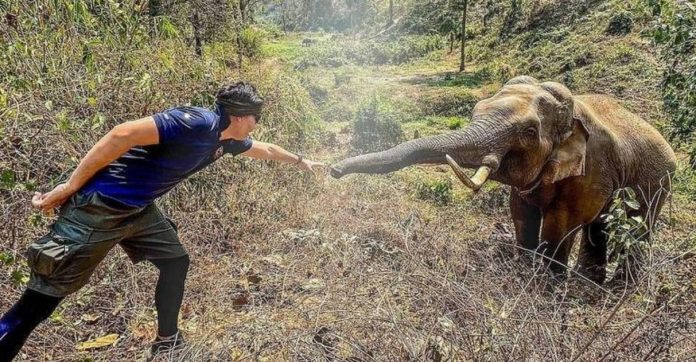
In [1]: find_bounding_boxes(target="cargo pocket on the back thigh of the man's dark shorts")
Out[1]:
[26,224,92,276]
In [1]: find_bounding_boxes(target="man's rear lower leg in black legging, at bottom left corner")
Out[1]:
[0,289,63,362]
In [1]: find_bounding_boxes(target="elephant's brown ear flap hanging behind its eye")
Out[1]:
[541,117,590,184]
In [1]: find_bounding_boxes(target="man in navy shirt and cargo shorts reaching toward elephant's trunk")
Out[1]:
[0,82,321,361]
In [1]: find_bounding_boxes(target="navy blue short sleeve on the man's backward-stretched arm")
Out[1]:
[152,107,216,144]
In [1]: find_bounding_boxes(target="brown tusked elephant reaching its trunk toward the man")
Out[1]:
[330,76,676,284]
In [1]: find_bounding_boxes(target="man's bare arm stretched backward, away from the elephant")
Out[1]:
[31,117,159,212]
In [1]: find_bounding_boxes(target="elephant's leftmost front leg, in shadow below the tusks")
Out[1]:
[510,191,541,250]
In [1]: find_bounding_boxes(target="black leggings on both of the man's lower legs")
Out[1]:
[0,255,189,362]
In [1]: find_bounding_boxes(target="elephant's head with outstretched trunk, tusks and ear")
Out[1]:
[331,76,589,190]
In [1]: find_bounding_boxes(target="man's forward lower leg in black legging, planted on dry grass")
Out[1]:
[150,255,190,338]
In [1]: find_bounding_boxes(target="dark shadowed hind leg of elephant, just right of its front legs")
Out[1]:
[578,222,607,284]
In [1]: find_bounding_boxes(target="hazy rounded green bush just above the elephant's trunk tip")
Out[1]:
[350,96,404,153]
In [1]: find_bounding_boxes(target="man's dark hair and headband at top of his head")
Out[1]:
[215,82,263,122]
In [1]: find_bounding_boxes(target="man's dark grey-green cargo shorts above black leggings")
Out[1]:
[26,193,187,297]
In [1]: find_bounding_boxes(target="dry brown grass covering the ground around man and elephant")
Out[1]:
[0,160,696,361]
